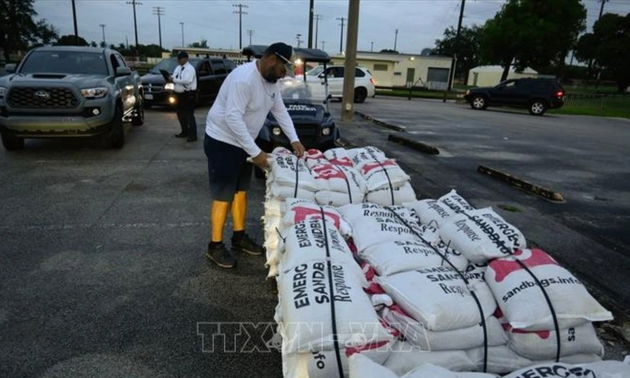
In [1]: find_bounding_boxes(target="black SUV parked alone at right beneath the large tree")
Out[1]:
[464,78,565,115]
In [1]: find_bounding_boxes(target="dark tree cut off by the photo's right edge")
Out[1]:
[575,13,630,92]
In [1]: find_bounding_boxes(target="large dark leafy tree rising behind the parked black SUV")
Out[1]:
[480,0,586,80]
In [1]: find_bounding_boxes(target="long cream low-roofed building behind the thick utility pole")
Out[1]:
[331,51,452,90]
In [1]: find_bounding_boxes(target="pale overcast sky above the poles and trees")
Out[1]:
[35,0,630,54]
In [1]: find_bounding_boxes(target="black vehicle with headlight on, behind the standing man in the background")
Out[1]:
[141,57,236,107]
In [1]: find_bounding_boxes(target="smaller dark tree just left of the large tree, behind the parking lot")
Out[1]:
[431,25,481,83]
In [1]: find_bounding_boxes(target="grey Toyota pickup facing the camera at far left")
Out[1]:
[0,46,144,150]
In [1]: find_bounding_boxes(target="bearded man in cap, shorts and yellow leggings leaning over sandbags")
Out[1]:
[204,43,304,268]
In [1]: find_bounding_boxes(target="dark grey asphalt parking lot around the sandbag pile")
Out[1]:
[0,98,630,377]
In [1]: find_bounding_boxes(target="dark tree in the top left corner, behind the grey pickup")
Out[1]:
[0,0,58,58]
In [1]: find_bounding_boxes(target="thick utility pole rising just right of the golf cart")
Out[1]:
[341,0,359,122]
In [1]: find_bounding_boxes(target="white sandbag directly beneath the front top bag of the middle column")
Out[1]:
[381,306,507,352]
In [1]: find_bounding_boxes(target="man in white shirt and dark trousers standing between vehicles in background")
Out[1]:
[170,51,197,142]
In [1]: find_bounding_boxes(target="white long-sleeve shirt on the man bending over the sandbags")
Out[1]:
[206,61,299,157]
